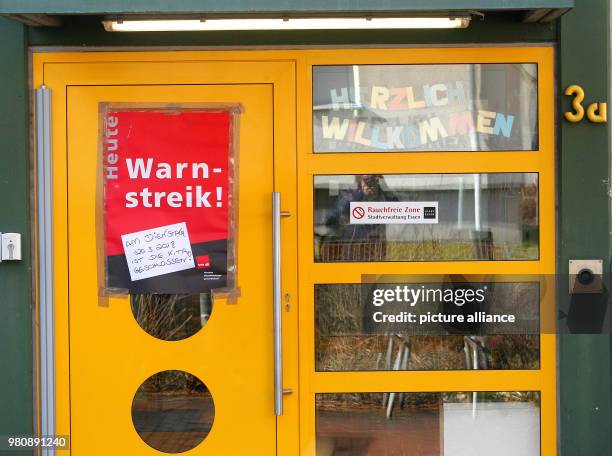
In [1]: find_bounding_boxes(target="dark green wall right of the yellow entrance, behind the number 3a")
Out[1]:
[558,0,612,456]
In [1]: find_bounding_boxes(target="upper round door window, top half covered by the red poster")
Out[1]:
[131,293,212,340]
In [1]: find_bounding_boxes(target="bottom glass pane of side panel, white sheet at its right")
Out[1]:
[316,391,540,456]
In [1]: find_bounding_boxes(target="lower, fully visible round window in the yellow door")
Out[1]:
[132,370,215,453]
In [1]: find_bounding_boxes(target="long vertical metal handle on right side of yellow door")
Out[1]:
[272,192,283,416]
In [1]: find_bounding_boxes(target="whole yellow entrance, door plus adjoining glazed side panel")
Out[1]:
[34,47,557,456]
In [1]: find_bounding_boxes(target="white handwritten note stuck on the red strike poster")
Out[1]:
[121,222,195,282]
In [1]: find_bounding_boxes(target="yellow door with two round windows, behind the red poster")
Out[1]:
[39,55,298,456]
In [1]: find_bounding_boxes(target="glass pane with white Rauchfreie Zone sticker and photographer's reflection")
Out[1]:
[314,173,539,262]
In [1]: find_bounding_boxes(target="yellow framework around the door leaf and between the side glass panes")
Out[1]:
[33,47,557,456]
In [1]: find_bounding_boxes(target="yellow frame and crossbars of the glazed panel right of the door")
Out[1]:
[297,47,556,456]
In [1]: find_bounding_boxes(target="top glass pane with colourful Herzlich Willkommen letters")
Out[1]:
[312,63,538,152]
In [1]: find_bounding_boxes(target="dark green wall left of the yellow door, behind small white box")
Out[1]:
[0,18,33,455]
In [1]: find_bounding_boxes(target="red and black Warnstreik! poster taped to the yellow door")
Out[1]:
[102,107,232,293]
